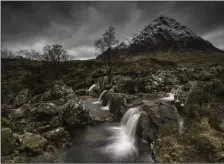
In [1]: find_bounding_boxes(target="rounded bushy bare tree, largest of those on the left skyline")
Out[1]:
[43,44,70,77]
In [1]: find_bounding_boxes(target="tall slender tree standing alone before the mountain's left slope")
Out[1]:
[95,26,118,86]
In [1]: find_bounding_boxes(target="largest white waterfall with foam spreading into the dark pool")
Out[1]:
[101,108,140,161]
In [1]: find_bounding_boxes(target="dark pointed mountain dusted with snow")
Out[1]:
[97,16,223,59]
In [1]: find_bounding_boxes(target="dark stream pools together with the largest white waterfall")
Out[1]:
[60,99,153,163]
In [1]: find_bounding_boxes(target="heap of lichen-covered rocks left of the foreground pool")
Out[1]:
[2,81,92,162]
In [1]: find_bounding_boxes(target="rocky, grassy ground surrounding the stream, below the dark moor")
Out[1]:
[1,65,224,163]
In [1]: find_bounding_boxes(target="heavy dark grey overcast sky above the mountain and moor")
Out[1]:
[1,1,224,59]
